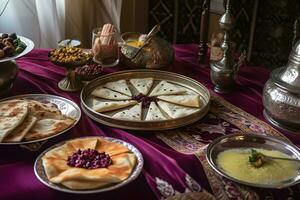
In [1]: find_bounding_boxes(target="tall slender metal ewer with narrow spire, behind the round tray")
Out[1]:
[210,0,239,93]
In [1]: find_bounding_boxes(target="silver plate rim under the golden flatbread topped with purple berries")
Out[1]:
[34,136,144,194]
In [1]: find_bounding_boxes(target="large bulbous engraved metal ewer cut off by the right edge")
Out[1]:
[263,40,300,133]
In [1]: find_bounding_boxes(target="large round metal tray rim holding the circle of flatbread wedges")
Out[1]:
[80,69,210,130]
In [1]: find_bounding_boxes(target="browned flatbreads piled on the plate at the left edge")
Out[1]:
[0,99,75,142]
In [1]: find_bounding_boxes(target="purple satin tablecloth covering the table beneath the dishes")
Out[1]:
[0,45,300,200]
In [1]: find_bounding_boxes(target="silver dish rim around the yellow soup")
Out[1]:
[206,134,300,189]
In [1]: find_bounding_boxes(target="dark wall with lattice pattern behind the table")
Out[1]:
[148,0,300,68]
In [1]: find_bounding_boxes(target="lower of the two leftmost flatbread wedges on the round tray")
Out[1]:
[92,98,138,112]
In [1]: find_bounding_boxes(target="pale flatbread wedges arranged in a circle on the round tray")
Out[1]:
[91,78,201,121]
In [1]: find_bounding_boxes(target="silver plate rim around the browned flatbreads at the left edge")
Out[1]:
[0,94,81,145]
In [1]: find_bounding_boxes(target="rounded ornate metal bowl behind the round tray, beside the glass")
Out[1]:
[121,32,174,69]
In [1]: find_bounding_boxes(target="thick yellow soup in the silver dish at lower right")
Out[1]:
[217,148,299,184]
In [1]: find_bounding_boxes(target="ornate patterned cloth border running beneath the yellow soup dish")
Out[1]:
[156,93,300,200]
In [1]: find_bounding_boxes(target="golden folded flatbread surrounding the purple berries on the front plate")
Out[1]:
[42,138,136,189]
